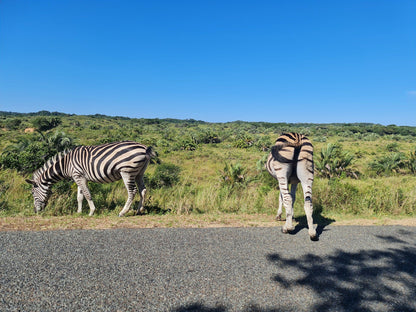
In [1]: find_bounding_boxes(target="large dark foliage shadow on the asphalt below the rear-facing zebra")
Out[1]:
[267,232,416,311]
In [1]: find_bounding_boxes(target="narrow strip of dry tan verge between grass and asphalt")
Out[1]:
[0,214,416,231]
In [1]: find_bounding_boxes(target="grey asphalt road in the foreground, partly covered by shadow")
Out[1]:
[0,226,416,312]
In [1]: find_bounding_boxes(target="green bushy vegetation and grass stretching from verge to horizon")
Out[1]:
[0,111,416,216]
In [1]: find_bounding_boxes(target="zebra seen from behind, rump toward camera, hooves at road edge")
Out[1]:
[266,133,317,240]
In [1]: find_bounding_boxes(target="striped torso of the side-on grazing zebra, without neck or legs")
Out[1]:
[69,141,153,183]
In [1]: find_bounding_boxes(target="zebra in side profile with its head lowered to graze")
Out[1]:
[26,141,156,217]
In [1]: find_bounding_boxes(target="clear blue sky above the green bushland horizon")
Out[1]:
[0,0,416,126]
